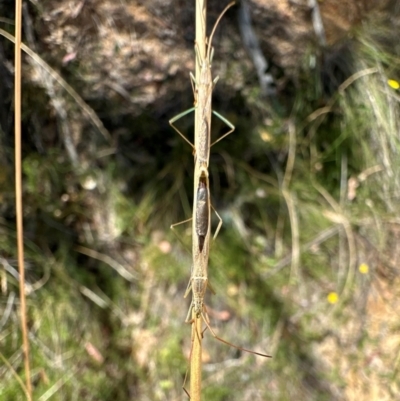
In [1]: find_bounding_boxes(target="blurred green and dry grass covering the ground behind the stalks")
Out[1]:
[0,5,400,401]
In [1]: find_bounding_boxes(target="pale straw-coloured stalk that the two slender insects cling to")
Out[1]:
[190,0,207,401]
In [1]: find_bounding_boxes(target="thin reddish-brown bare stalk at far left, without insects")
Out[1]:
[14,0,32,401]
